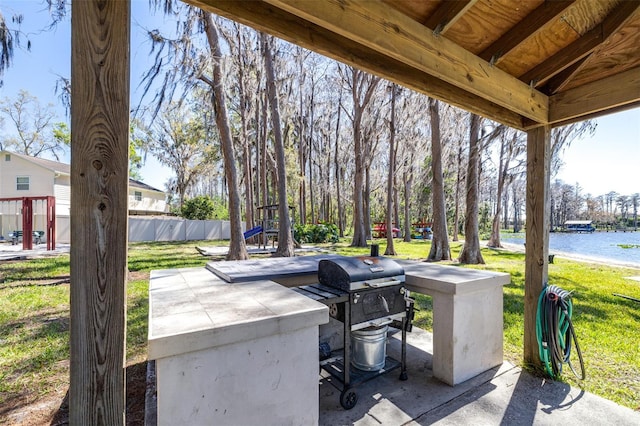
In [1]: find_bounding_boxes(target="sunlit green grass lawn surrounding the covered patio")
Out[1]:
[0,240,640,414]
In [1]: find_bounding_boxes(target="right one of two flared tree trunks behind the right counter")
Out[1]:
[458,114,484,265]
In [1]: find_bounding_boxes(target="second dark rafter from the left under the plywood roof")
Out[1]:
[478,0,575,64]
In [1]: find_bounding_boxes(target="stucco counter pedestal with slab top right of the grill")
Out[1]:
[402,262,511,386]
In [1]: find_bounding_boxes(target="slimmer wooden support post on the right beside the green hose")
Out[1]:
[524,126,551,368]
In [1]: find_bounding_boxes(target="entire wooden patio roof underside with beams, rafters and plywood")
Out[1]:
[186,0,640,130]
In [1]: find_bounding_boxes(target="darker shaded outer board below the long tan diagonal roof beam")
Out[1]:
[186,0,523,129]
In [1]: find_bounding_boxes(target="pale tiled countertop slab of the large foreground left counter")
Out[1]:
[148,268,329,359]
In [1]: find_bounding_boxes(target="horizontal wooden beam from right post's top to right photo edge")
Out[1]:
[549,67,640,124]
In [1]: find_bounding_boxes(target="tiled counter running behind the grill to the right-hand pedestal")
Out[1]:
[207,255,511,386]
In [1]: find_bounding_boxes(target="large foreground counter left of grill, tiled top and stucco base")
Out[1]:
[148,268,329,425]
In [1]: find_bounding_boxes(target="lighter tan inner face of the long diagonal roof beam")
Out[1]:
[262,0,548,123]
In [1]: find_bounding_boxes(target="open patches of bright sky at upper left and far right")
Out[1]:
[0,0,640,195]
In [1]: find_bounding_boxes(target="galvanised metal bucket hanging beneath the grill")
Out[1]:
[351,325,389,371]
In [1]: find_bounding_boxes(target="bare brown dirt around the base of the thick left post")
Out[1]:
[0,361,147,426]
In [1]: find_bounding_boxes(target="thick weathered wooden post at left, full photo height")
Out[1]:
[69,0,131,425]
